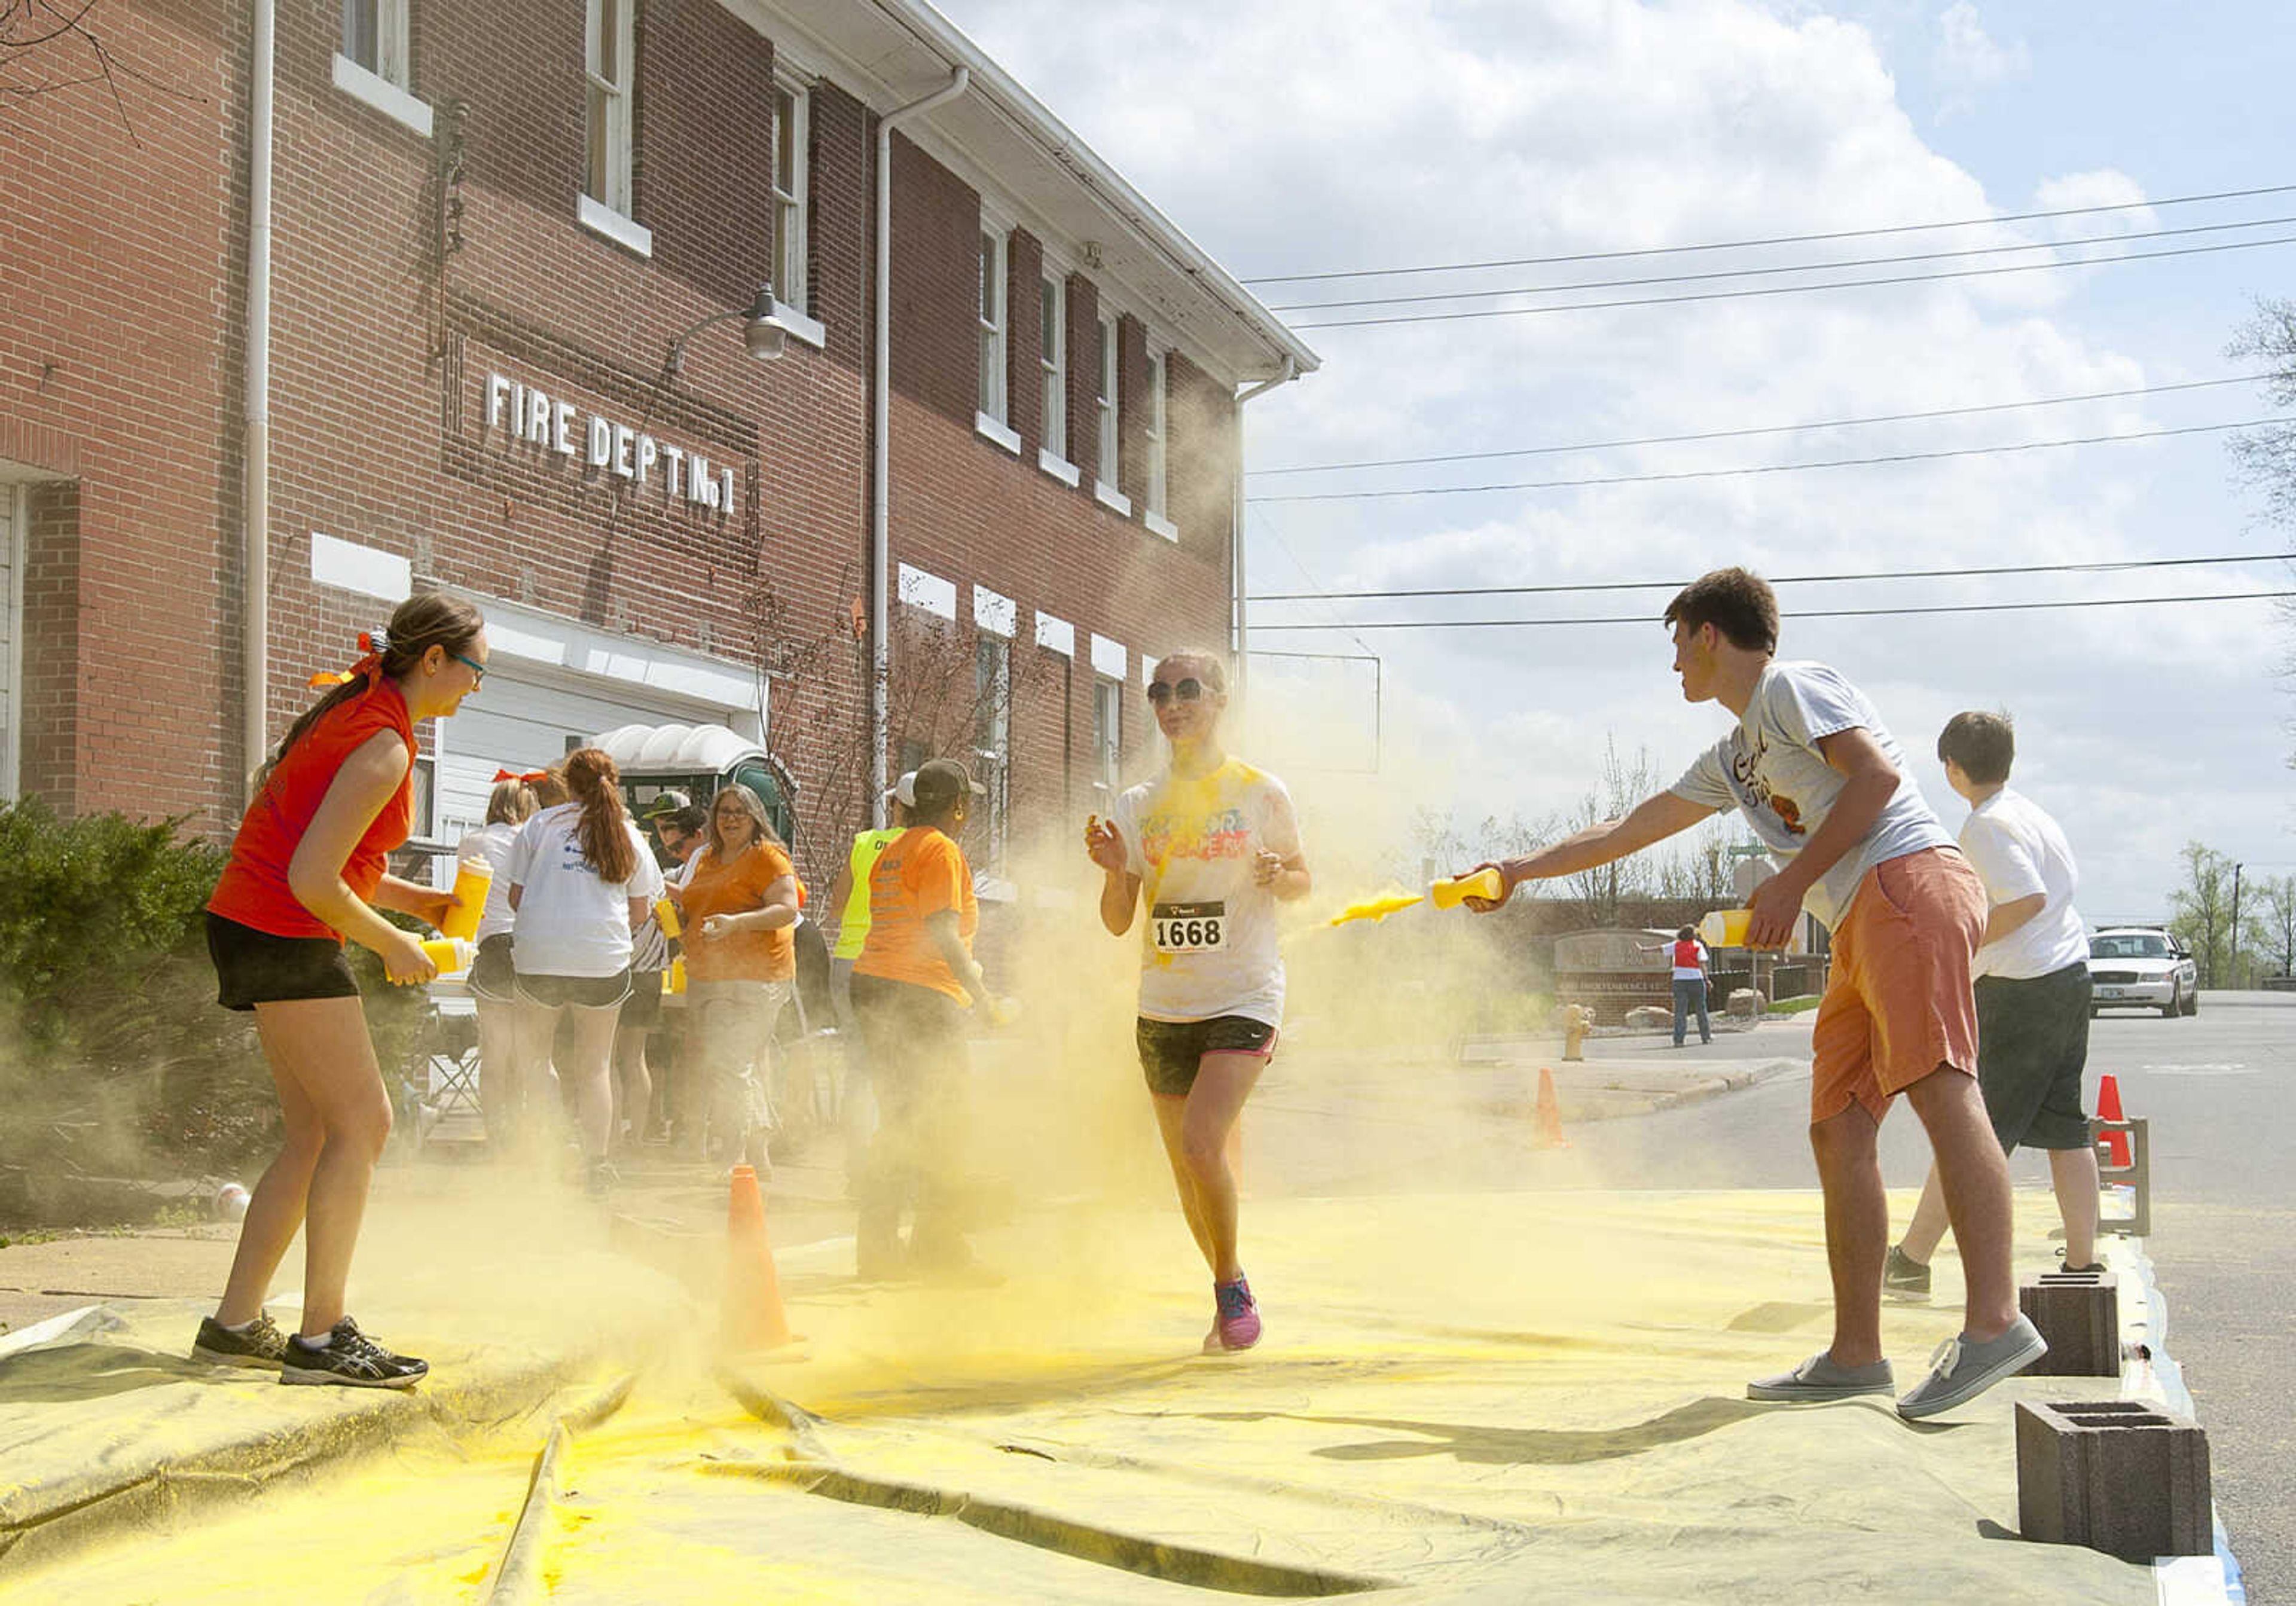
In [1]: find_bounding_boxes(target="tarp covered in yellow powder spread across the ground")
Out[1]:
[0,1190,2156,1606]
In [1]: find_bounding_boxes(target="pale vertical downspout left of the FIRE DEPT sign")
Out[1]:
[239,0,276,797]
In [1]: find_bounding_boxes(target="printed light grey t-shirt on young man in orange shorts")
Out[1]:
[1672,662,1954,930]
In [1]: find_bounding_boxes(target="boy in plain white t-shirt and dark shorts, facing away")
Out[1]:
[1883,712,2099,1300]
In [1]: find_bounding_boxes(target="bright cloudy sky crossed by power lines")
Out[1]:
[941,0,2296,921]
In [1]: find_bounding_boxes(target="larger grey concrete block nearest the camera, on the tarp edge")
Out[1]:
[2016,1399,2216,1562]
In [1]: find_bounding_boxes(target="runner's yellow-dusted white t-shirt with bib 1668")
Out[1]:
[1116,758,1299,1027]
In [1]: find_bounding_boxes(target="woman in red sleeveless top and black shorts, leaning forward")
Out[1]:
[191,593,487,1388]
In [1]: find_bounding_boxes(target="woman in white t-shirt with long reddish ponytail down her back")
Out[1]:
[505,747,661,1197]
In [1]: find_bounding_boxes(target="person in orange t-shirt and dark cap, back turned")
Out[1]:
[852,758,997,1278]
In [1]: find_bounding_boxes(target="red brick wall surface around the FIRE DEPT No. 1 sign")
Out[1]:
[0,0,1233,875]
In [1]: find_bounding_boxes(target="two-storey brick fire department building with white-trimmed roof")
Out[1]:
[0,0,1315,875]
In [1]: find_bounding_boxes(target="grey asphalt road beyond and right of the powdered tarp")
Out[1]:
[1513,993,2296,1601]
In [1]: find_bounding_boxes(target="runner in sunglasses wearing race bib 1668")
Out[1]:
[1083,652,1311,1353]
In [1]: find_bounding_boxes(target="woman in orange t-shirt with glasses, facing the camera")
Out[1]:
[670,783,799,1176]
